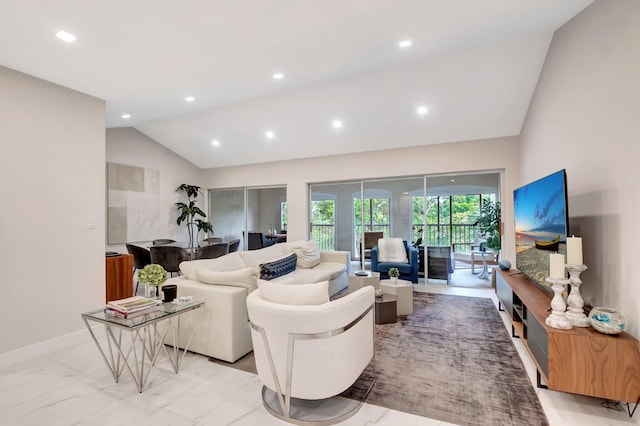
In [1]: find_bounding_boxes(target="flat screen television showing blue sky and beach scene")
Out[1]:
[513,169,569,294]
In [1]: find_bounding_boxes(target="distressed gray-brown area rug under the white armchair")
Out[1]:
[212,293,548,425]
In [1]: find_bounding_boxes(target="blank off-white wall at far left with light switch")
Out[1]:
[0,67,105,353]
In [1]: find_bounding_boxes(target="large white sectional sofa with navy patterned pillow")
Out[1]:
[165,241,351,362]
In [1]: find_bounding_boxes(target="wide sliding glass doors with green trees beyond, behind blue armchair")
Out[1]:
[309,173,500,277]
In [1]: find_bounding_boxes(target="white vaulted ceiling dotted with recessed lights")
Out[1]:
[0,0,592,168]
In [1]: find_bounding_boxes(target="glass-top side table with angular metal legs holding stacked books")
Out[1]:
[82,300,204,392]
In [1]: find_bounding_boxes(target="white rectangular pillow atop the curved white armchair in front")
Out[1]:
[258,280,329,305]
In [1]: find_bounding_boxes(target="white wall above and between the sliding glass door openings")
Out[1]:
[204,137,519,259]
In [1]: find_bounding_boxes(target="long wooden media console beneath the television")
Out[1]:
[496,270,640,404]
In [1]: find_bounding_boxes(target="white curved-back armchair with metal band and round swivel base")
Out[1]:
[247,286,375,424]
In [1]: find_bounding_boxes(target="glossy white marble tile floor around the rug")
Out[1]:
[0,284,640,426]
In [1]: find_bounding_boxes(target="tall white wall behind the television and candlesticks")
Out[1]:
[518,0,640,337]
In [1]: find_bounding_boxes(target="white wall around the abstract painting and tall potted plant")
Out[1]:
[106,127,208,253]
